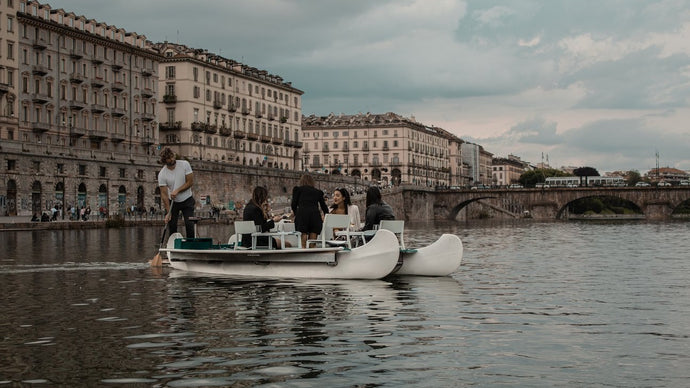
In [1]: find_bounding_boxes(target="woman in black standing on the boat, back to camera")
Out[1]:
[290,174,328,247]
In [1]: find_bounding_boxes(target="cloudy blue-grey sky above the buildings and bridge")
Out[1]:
[48,0,690,172]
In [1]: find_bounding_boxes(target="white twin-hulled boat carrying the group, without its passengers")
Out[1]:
[161,229,463,279]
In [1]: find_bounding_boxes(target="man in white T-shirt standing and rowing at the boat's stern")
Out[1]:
[158,147,196,238]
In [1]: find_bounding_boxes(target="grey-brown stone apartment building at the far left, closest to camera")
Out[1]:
[0,0,160,215]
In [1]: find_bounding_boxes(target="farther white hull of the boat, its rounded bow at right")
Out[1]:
[394,234,463,276]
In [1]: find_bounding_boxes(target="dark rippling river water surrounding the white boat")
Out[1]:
[0,221,690,387]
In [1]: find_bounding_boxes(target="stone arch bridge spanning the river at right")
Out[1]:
[402,186,690,219]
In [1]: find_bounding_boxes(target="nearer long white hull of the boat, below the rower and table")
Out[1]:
[162,230,398,279]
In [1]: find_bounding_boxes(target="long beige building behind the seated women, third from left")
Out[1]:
[302,112,450,187]
